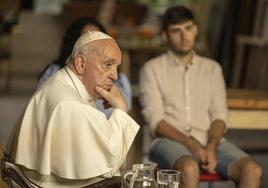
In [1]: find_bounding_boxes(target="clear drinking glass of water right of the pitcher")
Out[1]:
[157,169,181,188]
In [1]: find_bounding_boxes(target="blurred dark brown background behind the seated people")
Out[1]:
[0,0,268,187]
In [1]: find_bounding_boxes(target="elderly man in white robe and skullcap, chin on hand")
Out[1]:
[7,31,139,187]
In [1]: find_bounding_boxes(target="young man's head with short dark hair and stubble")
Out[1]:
[162,5,197,56]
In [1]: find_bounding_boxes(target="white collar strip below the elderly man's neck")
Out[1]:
[64,66,95,106]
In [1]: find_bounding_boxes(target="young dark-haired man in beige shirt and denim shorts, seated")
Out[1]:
[140,6,262,188]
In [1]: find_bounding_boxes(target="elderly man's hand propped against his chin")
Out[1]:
[95,85,127,112]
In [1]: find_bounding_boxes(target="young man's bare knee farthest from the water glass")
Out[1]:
[242,159,262,179]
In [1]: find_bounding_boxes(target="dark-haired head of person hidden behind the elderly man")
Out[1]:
[56,16,106,67]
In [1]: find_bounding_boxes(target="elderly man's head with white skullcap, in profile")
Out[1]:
[68,31,121,99]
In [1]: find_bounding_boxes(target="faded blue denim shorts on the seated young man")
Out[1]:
[149,138,248,178]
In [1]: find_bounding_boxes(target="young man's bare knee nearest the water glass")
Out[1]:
[175,156,199,175]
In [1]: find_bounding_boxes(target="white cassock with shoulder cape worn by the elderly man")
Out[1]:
[7,67,139,187]
